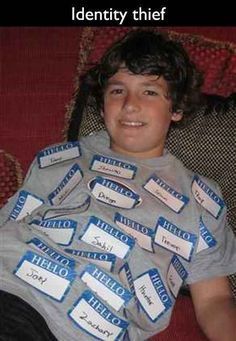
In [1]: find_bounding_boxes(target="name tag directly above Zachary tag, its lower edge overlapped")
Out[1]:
[80,264,133,311]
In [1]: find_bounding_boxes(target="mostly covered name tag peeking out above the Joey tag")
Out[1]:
[27,238,75,269]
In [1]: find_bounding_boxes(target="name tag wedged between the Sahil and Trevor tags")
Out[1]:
[114,213,154,252]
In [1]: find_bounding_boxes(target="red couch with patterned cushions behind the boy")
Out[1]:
[0,27,236,341]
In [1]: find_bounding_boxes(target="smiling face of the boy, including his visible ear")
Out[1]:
[102,69,182,158]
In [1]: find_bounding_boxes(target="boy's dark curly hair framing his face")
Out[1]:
[68,29,203,140]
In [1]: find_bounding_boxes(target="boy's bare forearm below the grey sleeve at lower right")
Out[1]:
[190,277,236,341]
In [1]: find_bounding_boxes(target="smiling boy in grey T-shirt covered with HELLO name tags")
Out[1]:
[1,31,236,340]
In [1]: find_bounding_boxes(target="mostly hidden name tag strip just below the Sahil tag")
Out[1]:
[64,249,116,272]
